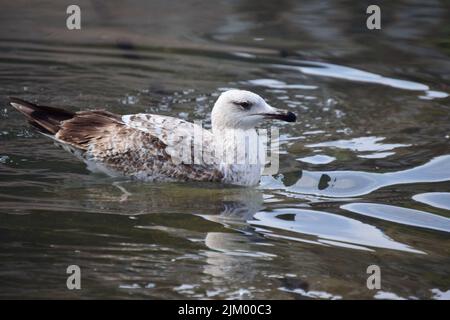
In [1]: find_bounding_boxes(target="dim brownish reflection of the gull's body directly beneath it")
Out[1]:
[68,181,263,218]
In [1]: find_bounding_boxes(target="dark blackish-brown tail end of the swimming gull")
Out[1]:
[9,97,75,135]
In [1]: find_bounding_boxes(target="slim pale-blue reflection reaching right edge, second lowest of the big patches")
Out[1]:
[341,203,450,232]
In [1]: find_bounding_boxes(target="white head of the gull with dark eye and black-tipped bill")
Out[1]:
[211,90,296,131]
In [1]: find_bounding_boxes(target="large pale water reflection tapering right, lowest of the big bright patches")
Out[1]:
[248,208,424,253]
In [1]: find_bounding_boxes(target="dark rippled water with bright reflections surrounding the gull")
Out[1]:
[0,0,450,299]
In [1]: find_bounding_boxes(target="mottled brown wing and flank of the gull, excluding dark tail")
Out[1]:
[55,111,223,181]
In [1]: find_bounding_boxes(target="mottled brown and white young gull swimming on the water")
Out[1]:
[10,89,296,186]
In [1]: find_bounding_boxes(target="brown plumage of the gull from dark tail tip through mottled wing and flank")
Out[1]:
[11,98,223,182]
